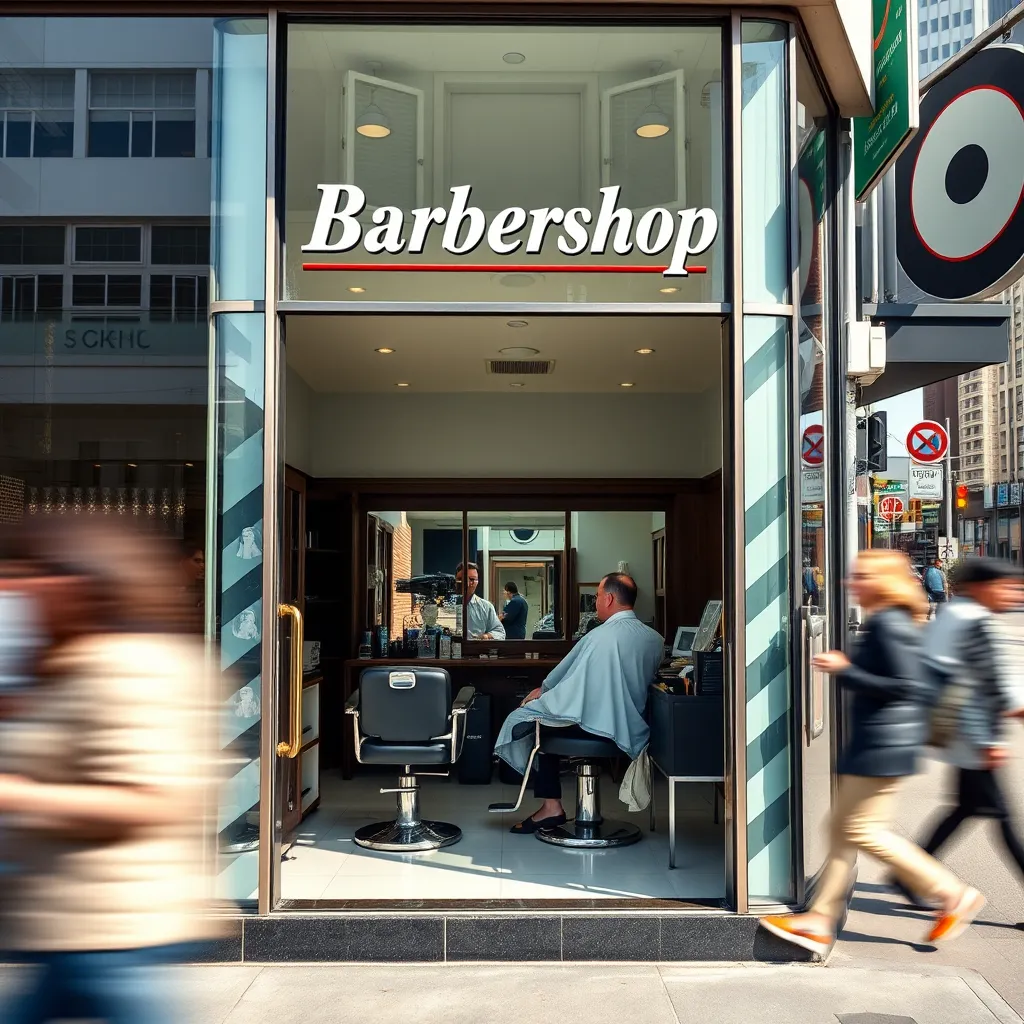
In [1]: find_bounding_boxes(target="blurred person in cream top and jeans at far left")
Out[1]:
[0,518,222,1024]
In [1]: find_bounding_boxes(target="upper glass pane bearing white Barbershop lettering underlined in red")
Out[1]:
[285,25,725,303]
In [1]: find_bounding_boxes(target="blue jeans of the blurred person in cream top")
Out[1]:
[0,946,199,1024]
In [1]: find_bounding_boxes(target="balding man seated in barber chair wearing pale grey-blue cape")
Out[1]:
[495,572,665,835]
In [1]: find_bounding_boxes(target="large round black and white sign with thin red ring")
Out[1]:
[896,46,1024,300]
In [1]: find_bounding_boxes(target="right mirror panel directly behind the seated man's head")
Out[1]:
[571,512,666,637]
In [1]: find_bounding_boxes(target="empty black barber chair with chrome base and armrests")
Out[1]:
[345,667,476,853]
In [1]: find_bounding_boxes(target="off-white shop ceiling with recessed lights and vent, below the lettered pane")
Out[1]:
[285,313,722,394]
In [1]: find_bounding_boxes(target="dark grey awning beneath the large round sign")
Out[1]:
[863,302,1011,403]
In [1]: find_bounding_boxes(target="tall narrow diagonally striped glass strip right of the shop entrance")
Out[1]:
[741,23,795,904]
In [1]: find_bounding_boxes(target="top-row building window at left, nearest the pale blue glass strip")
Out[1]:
[89,72,196,157]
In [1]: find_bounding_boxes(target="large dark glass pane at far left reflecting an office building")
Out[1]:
[0,9,228,897]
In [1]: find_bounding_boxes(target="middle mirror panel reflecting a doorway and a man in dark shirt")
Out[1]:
[468,512,565,640]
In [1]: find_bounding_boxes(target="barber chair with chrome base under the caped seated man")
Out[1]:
[487,722,643,850]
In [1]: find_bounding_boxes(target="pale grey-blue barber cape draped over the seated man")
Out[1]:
[495,611,665,774]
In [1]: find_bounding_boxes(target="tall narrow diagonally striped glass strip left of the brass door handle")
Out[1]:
[209,18,267,899]
